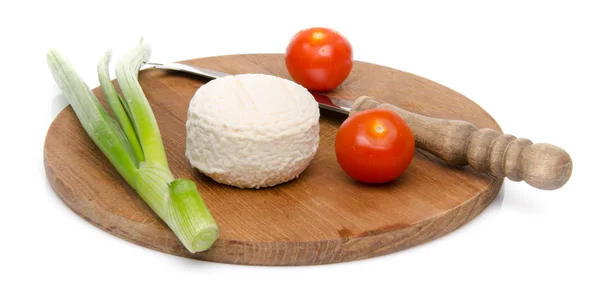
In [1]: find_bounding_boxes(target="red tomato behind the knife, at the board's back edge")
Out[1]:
[285,27,353,92]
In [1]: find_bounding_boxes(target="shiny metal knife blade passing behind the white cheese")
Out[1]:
[146,62,354,115]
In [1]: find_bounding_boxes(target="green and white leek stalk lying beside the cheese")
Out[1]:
[47,41,219,253]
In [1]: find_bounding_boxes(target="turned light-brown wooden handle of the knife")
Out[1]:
[350,96,573,190]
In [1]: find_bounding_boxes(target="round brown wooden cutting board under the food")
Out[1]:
[44,54,503,265]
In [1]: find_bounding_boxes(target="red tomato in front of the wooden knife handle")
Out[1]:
[335,108,415,183]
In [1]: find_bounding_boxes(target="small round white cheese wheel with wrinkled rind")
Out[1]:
[185,74,319,188]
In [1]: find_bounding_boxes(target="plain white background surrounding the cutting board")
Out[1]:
[0,0,600,299]
